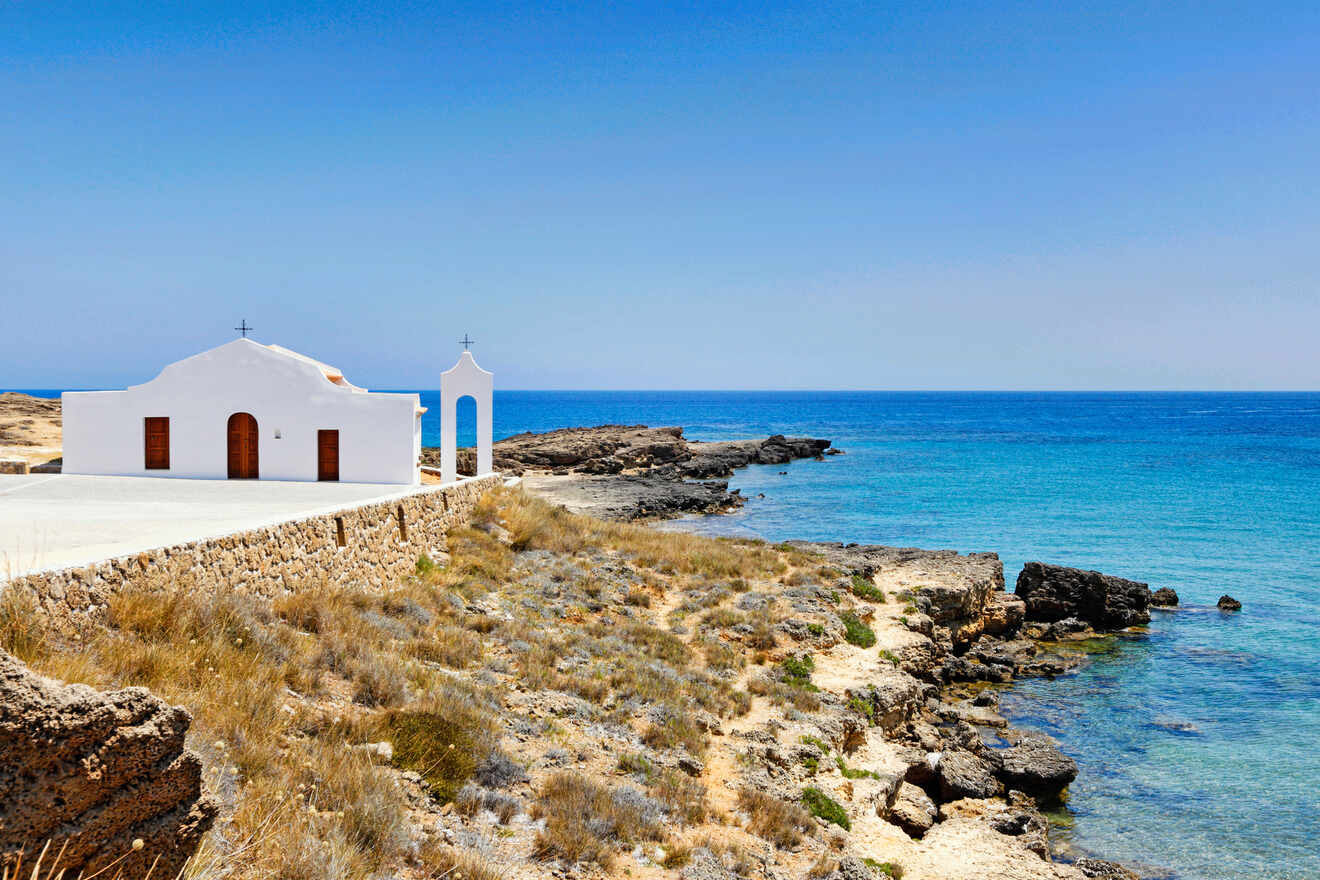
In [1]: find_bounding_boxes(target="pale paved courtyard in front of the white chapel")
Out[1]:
[0,474,432,581]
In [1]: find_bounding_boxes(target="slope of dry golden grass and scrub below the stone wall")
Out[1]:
[0,491,897,880]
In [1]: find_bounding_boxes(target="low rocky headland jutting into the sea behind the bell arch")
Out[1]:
[422,425,841,521]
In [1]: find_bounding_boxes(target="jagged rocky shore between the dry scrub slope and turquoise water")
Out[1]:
[770,541,1176,880]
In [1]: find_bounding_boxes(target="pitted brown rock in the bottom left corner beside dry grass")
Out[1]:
[0,652,216,877]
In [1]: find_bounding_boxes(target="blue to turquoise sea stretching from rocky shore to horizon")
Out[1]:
[12,392,1320,880]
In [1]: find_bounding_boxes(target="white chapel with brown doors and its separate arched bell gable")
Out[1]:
[62,338,494,486]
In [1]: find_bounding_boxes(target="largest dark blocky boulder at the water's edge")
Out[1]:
[1015,562,1151,631]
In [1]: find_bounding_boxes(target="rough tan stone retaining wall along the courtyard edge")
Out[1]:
[3,475,502,620]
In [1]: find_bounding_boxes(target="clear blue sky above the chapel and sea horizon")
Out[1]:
[0,0,1320,389]
